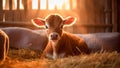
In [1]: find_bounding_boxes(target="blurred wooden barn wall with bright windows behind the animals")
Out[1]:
[0,0,120,33]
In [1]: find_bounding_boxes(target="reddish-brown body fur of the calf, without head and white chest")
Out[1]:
[42,32,89,58]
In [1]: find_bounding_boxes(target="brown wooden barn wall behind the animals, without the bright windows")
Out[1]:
[0,0,117,33]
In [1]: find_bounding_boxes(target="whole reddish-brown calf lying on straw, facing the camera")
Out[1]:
[32,14,89,59]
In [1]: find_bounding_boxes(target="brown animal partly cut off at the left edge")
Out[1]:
[0,30,9,64]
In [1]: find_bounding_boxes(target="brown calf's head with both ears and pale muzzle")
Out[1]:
[32,14,76,41]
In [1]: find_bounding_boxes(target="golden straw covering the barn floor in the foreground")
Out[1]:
[0,49,120,68]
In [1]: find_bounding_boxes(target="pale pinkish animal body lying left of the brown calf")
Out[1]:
[1,27,48,52]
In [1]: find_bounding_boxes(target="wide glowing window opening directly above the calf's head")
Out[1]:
[32,0,77,10]
